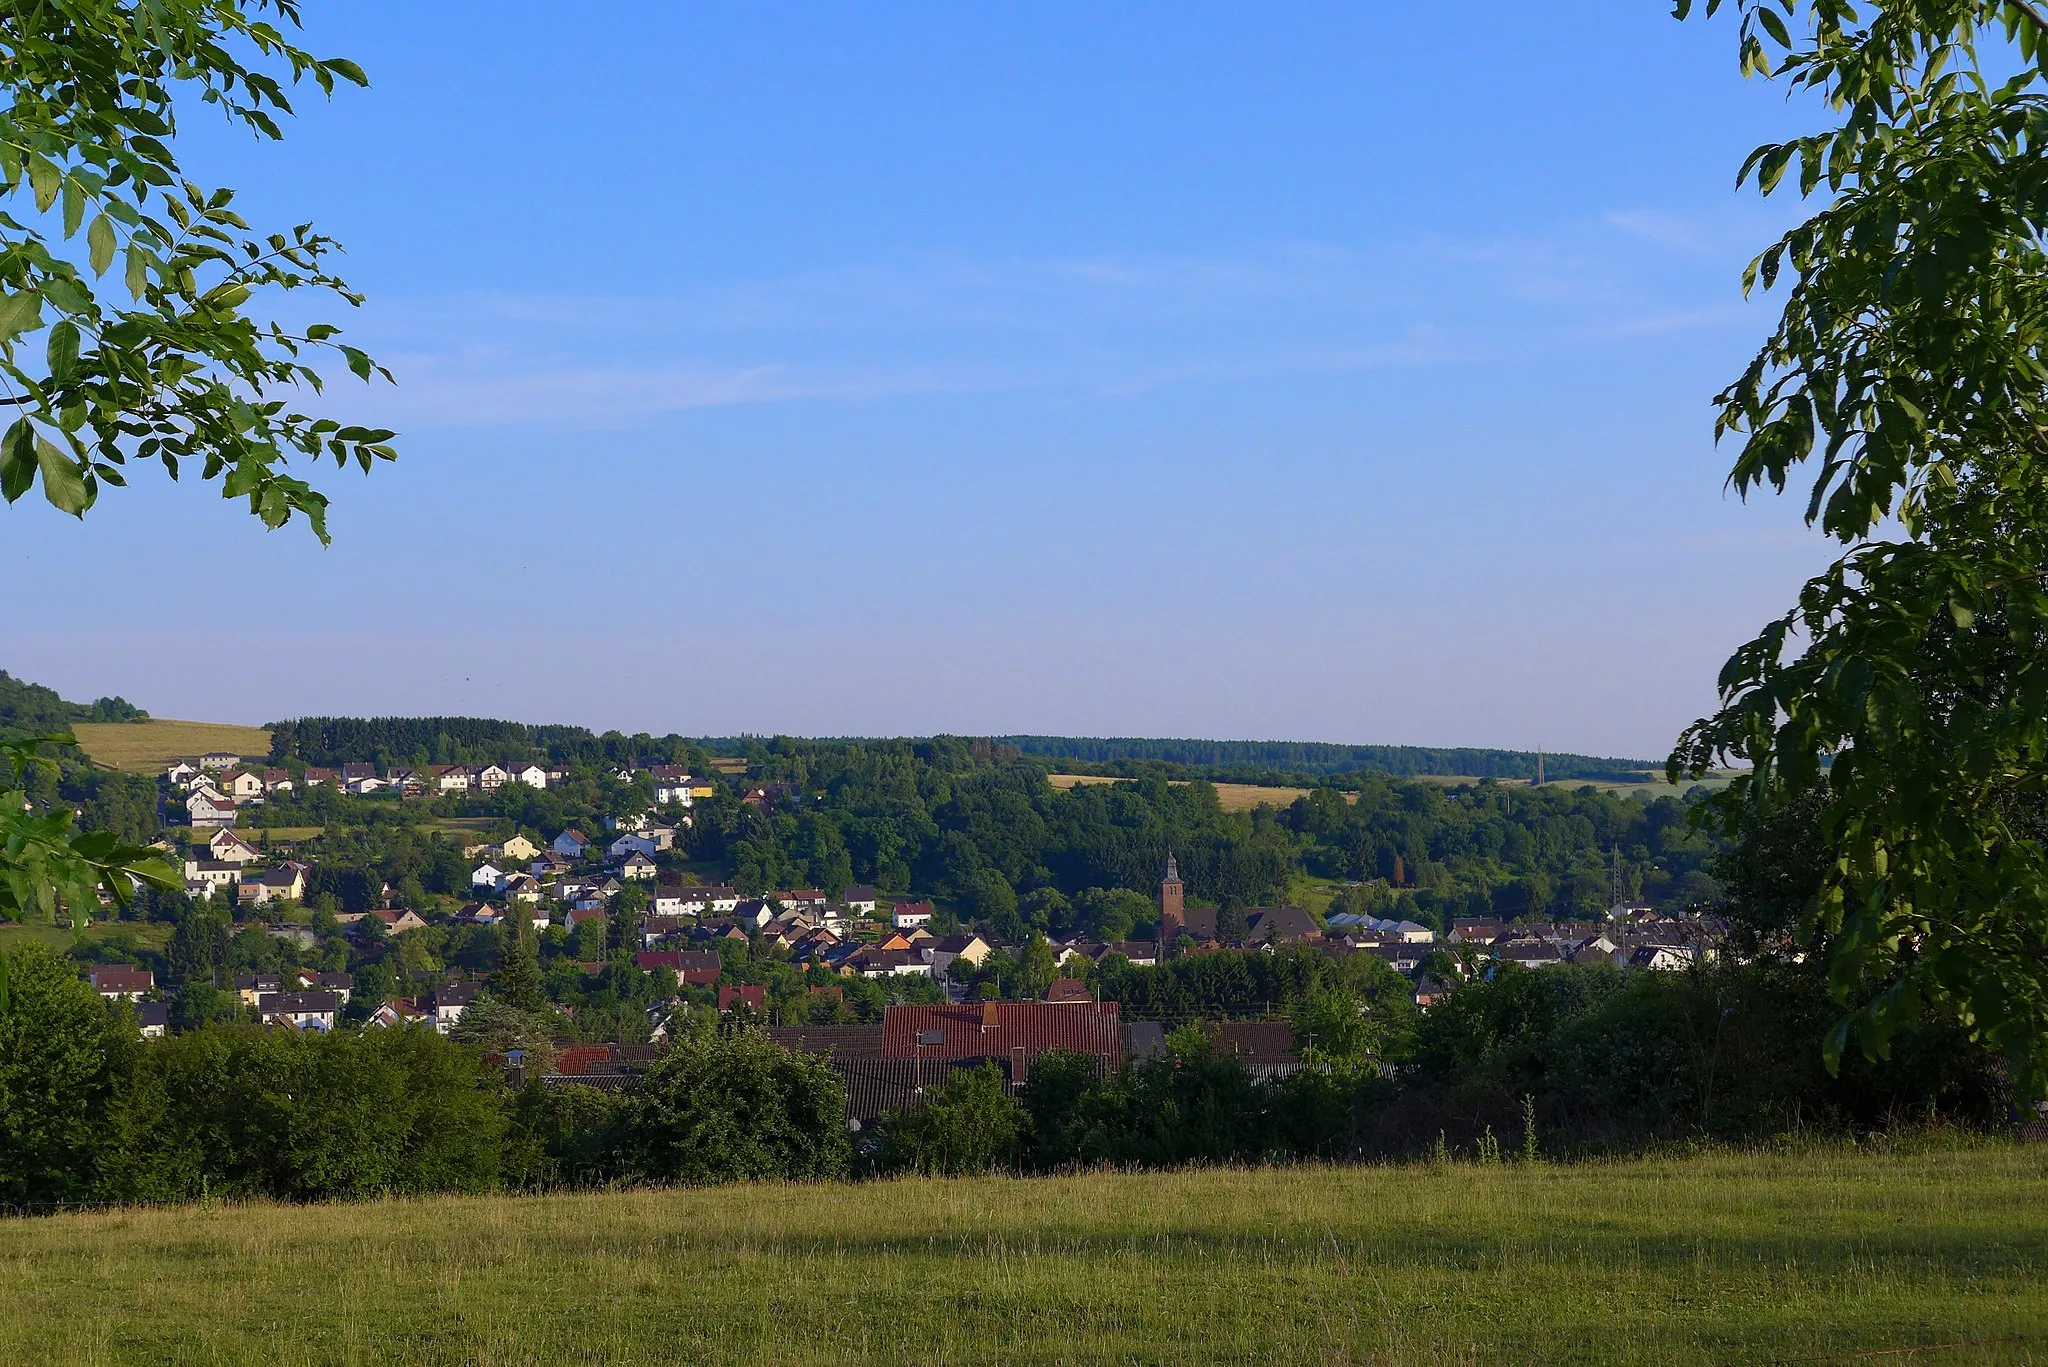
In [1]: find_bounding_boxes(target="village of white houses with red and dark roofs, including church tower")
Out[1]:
[59,754,1726,1123]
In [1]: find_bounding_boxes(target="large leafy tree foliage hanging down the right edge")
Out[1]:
[1669,0,2048,1096]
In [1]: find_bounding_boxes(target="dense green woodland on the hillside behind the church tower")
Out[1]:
[679,738,1718,926]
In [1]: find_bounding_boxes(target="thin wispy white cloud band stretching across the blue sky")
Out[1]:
[339,211,1757,426]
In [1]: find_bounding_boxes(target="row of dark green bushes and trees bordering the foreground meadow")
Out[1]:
[0,945,2009,1205]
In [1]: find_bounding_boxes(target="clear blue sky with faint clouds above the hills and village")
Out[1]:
[0,0,1825,756]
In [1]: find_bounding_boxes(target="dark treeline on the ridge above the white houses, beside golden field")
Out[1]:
[268,717,702,767]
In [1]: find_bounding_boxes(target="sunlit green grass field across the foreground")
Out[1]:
[0,1146,2048,1365]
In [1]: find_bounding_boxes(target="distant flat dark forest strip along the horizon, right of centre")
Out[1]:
[997,736,1655,783]
